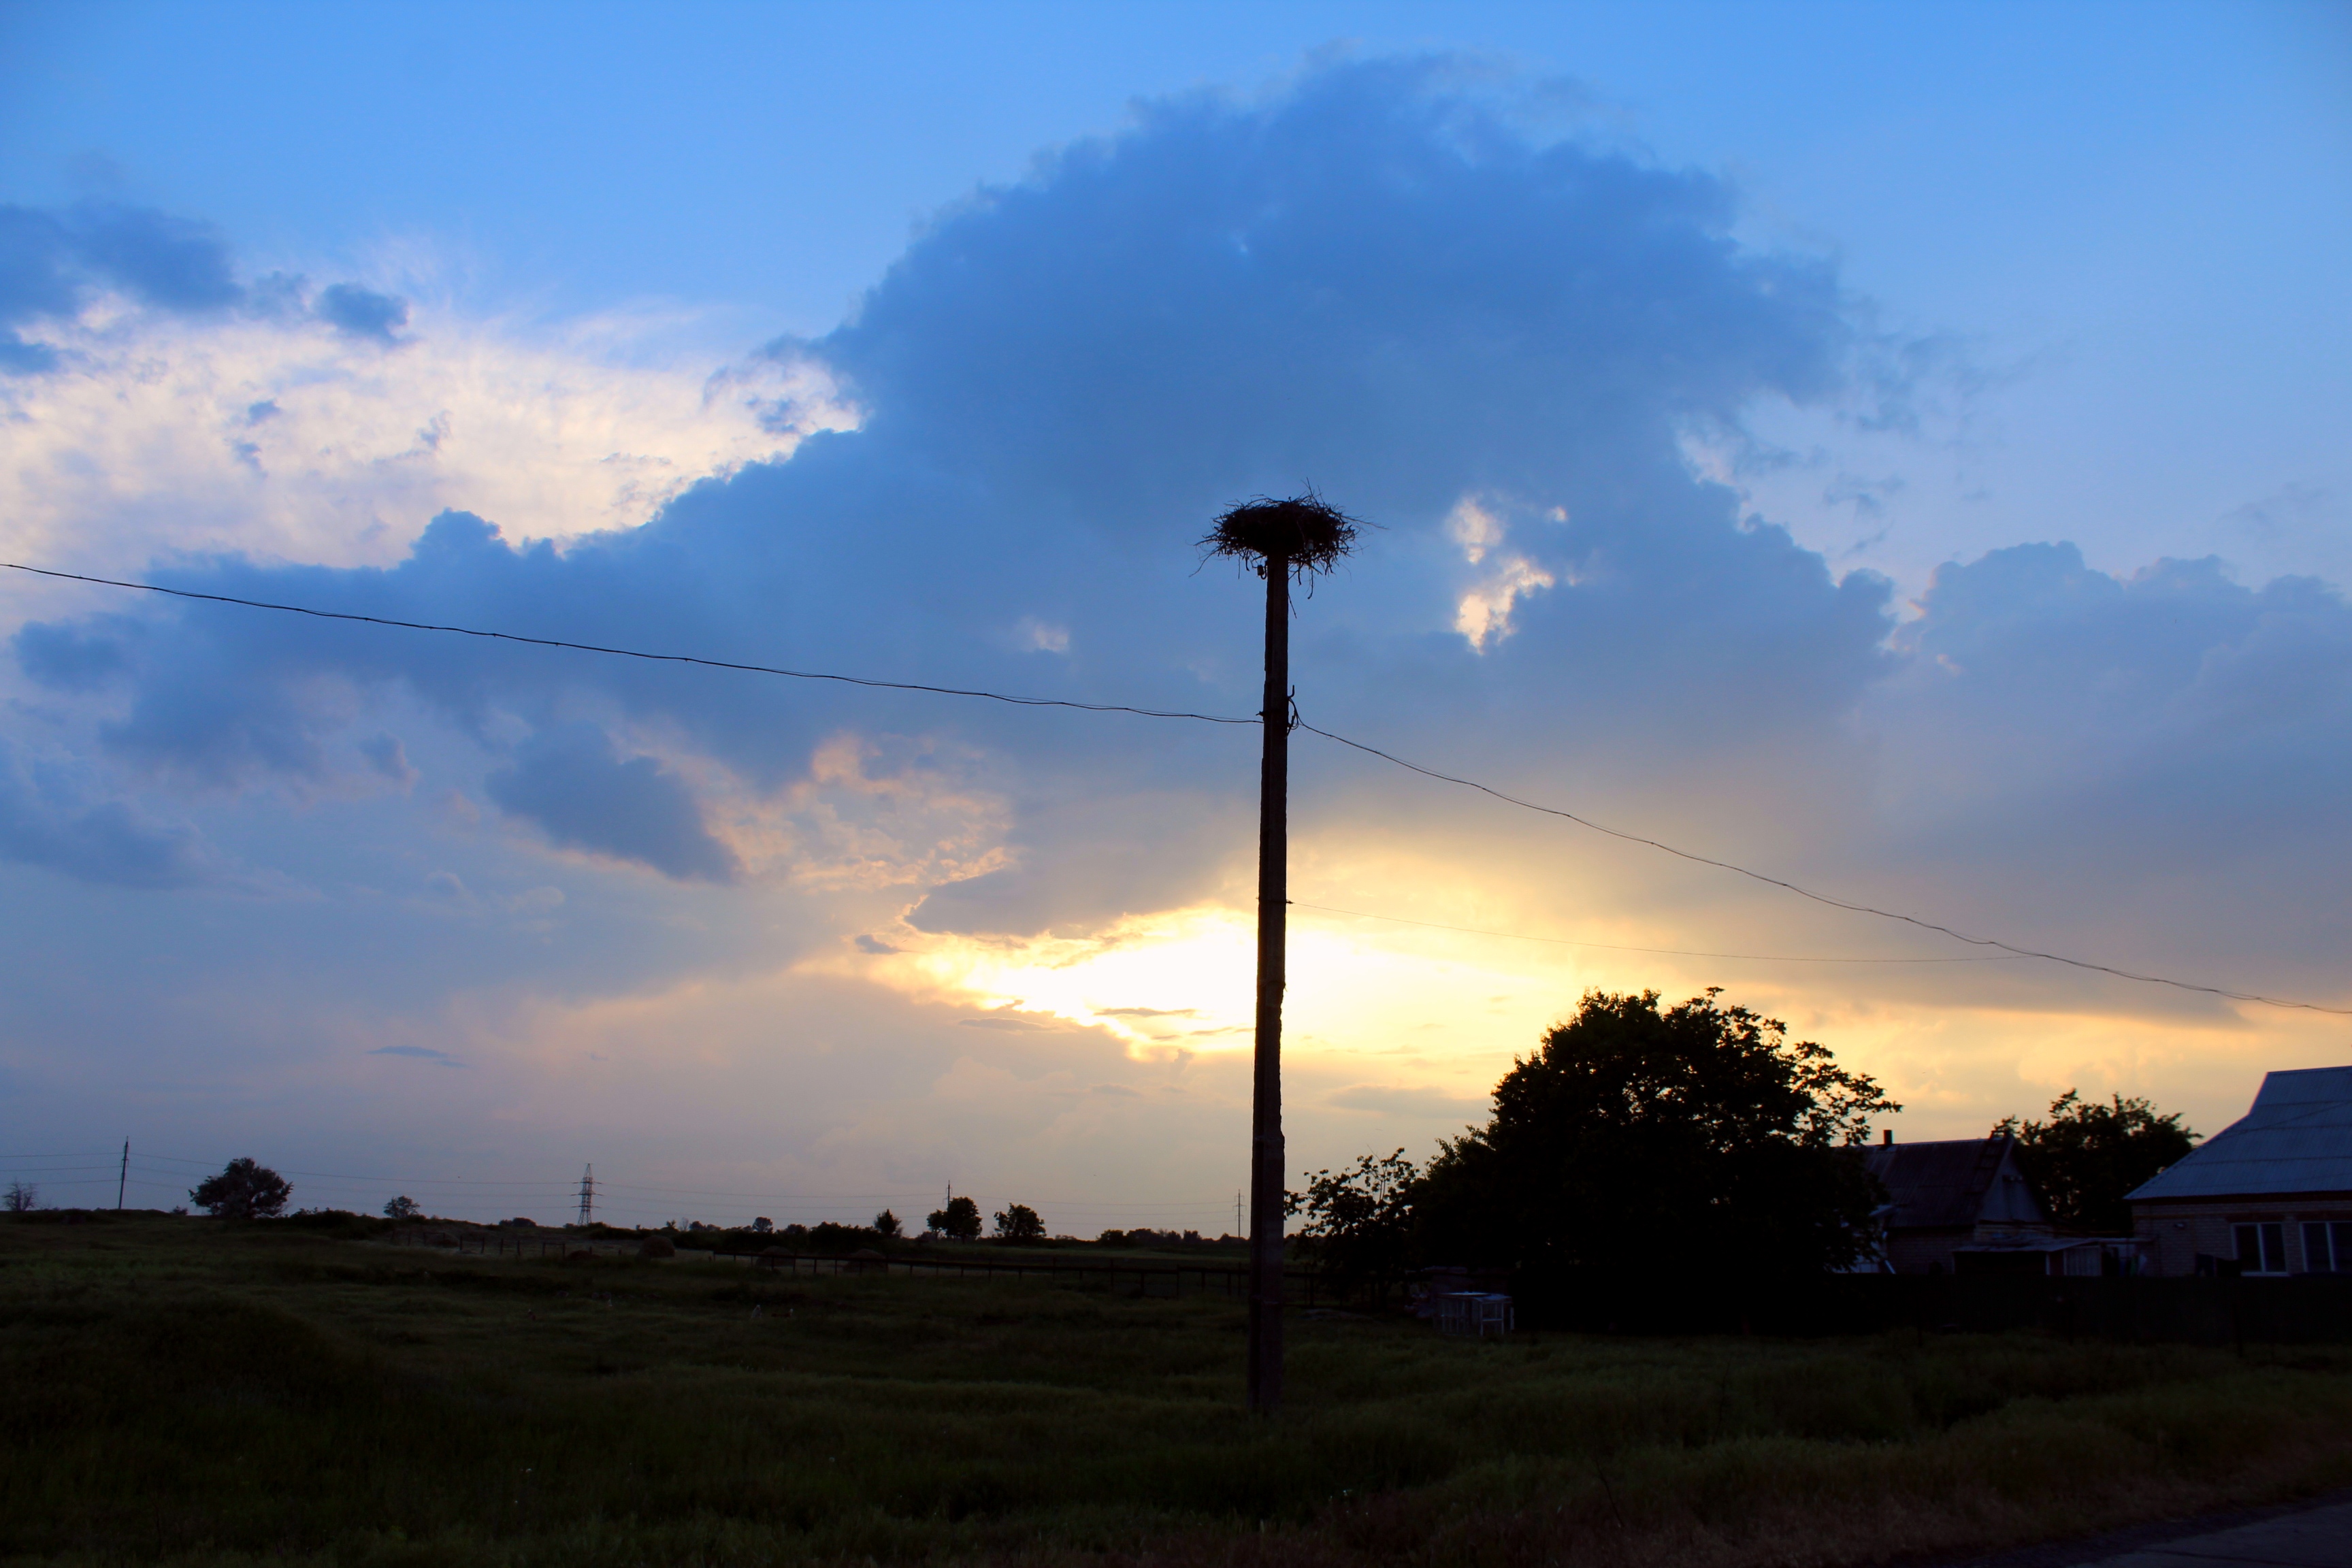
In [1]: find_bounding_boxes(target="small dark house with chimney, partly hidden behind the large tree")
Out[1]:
[1863,1133,2065,1274]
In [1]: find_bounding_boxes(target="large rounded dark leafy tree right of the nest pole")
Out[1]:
[1414,990,1900,1279]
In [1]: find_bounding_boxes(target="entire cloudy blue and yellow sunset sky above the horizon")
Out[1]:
[0,2,2352,1234]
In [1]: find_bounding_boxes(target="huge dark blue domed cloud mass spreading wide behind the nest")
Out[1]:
[19,61,2352,992]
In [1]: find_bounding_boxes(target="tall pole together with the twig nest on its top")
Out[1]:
[1202,491,1357,1415]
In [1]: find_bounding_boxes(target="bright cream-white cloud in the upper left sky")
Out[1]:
[0,236,854,592]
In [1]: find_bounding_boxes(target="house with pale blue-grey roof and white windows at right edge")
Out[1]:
[2126,1067,2352,1274]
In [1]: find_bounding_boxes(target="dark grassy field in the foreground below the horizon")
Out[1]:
[0,1215,2352,1568]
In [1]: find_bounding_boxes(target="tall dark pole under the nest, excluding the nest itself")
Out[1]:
[1249,555,1291,1415]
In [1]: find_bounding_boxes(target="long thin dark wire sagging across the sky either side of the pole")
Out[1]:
[14,562,2352,1018]
